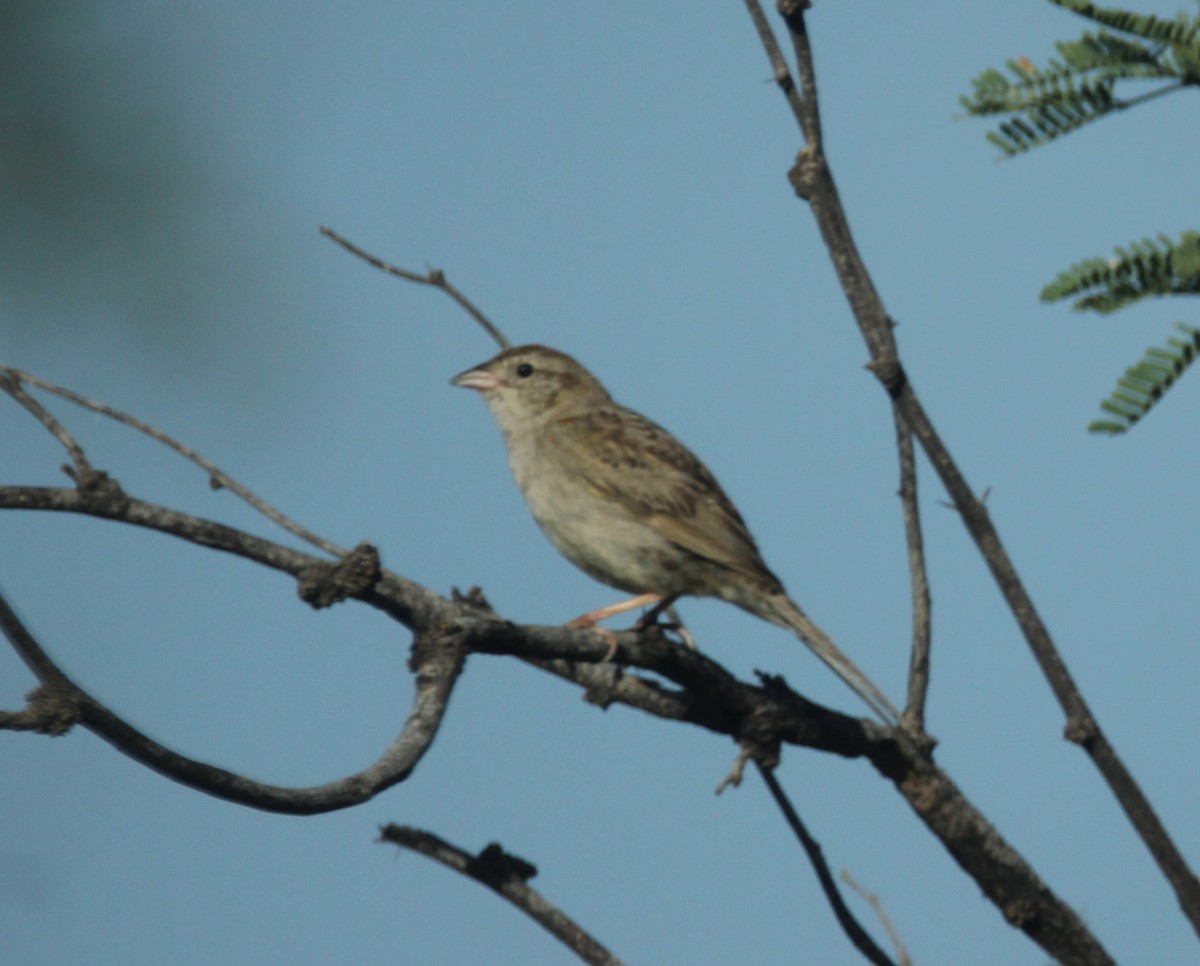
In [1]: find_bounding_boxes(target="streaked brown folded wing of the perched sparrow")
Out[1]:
[546,406,770,578]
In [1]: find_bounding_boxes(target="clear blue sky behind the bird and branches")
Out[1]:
[0,0,1200,965]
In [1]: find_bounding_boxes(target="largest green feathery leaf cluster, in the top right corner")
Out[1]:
[960,0,1200,157]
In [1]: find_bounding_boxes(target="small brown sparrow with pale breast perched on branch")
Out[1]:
[450,344,900,724]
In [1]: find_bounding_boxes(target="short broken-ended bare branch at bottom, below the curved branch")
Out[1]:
[379,824,622,966]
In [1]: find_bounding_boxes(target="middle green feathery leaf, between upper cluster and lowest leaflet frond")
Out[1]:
[1042,232,1200,314]
